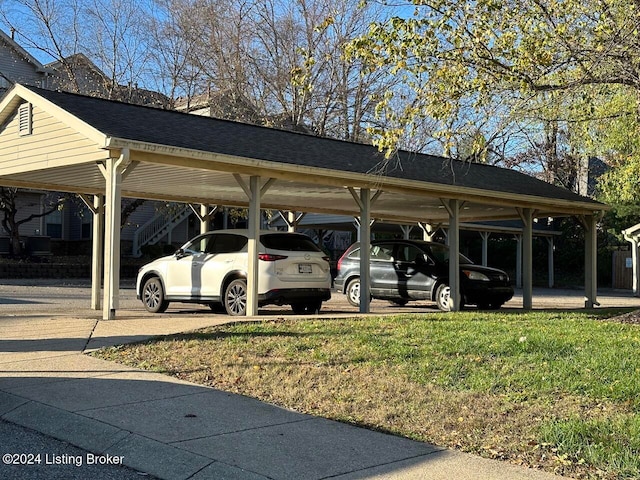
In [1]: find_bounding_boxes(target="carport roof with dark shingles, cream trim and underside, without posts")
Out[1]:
[0,85,607,221]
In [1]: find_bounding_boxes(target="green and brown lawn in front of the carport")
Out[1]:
[96,310,640,479]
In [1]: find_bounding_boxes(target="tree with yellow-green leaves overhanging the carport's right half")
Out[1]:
[350,0,640,169]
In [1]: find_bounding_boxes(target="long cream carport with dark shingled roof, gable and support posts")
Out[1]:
[0,85,607,319]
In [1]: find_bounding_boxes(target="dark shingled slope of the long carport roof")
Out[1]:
[28,87,606,206]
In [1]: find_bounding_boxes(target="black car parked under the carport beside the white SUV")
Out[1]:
[334,240,513,311]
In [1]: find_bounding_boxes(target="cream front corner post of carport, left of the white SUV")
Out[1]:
[100,149,130,320]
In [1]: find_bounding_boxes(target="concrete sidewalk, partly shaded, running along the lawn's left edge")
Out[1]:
[0,308,576,480]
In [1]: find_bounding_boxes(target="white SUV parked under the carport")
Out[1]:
[136,230,331,315]
